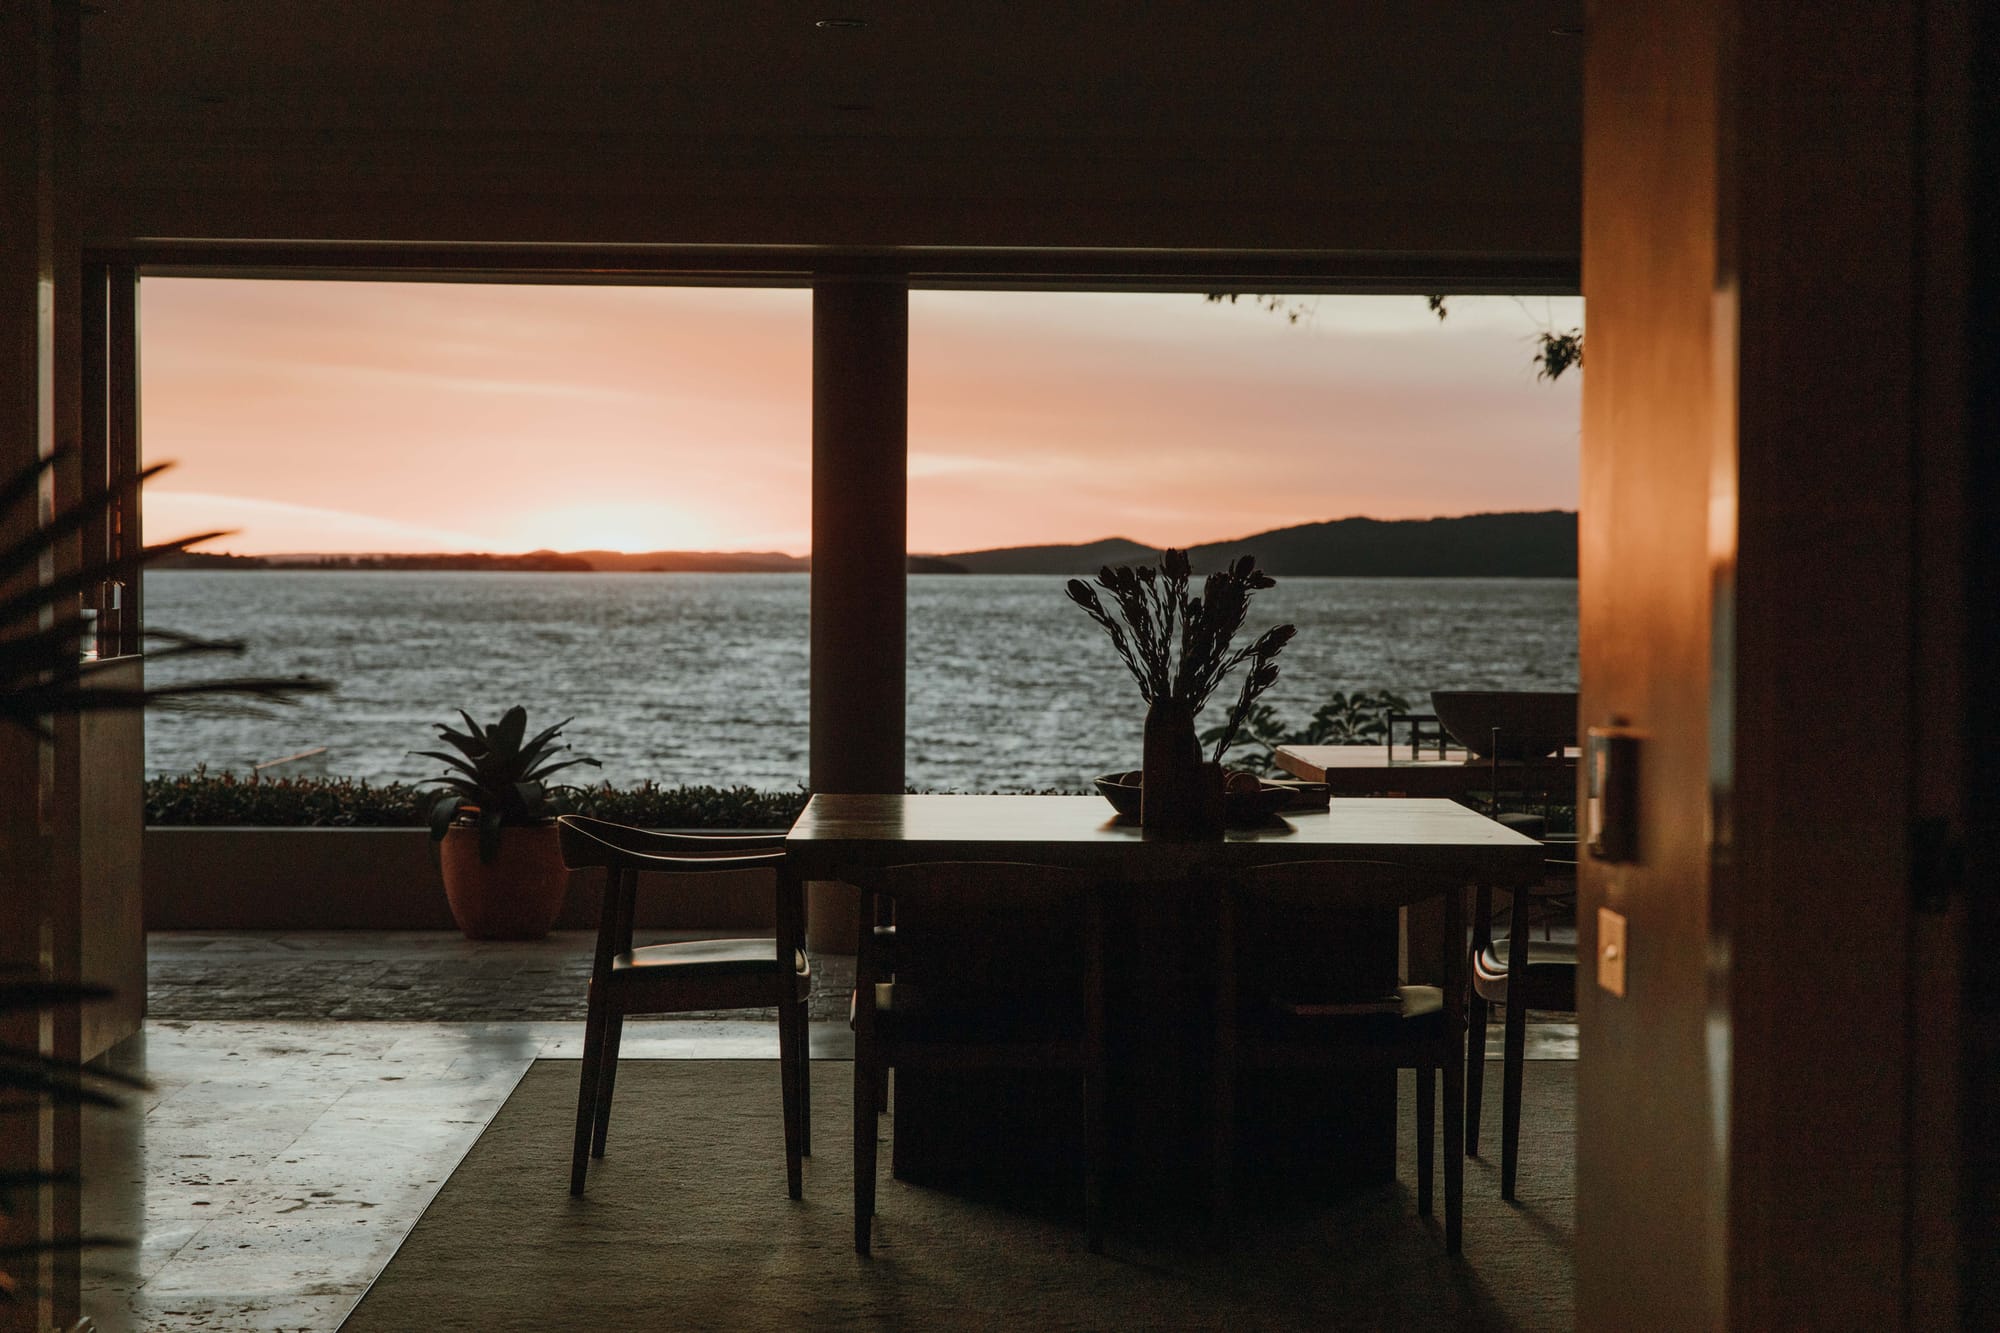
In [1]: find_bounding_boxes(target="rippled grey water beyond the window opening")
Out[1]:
[146,570,1576,791]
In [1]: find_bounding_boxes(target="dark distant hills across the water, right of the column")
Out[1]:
[942,508,1576,578]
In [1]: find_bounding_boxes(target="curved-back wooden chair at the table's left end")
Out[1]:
[556,815,812,1199]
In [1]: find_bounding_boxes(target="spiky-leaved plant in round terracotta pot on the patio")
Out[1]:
[414,707,598,939]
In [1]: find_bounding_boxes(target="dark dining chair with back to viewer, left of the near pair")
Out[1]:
[844,861,1104,1255]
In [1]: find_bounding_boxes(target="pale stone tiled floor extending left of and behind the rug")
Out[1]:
[84,935,1576,1333]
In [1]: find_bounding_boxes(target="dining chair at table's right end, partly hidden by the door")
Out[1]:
[1466,856,1576,1199]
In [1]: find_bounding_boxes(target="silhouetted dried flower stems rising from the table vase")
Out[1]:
[1064,550,1298,763]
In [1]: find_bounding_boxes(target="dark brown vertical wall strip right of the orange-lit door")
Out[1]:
[1730,2,1962,1327]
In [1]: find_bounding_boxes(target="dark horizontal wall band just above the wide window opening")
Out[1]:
[86,132,1576,256]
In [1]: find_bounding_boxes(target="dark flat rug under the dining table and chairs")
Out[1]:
[342,1061,1576,1333]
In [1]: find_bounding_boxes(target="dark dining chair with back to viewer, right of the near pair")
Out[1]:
[1210,861,1466,1255]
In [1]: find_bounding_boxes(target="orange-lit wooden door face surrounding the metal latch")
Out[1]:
[1576,4,1734,1329]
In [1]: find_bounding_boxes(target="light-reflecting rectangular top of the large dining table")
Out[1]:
[786,793,1542,885]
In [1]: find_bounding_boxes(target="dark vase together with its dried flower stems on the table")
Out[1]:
[1064,550,1298,833]
